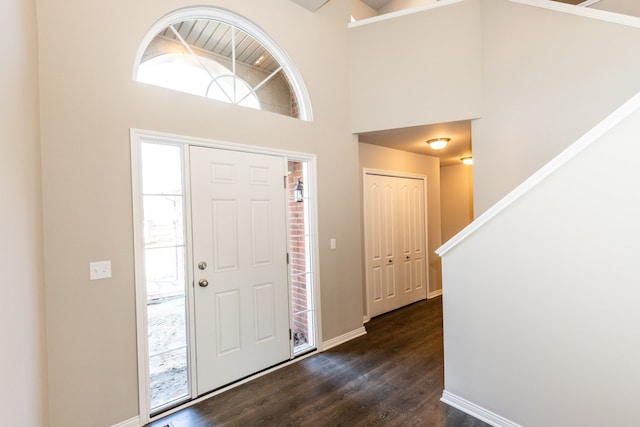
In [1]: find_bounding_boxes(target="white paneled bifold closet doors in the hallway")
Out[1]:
[364,174,427,317]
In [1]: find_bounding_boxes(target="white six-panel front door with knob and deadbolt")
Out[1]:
[190,147,291,395]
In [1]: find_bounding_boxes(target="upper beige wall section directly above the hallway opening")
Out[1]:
[349,0,482,133]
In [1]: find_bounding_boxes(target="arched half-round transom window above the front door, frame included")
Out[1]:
[134,8,312,121]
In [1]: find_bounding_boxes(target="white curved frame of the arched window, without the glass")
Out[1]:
[132,7,313,122]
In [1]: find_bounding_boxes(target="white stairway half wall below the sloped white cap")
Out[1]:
[443,102,640,426]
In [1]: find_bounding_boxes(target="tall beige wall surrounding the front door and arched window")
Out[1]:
[38,0,362,427]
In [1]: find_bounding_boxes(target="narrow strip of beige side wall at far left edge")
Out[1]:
[0,0,48,427]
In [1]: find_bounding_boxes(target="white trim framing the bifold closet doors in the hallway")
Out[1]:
[362,168,430,322]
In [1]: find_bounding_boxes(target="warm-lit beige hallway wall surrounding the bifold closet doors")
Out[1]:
[360,143,442,293]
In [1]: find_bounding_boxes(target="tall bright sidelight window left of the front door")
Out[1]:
[140,143,189,412]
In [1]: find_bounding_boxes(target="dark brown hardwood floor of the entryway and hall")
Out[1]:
[151,298,488,427]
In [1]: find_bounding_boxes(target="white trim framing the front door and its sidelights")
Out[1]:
[130,128,322,425]
